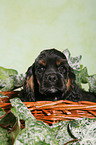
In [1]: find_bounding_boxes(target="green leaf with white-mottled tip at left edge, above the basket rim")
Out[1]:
[0,67,25,91]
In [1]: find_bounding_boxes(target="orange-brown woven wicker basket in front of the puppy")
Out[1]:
[0,92,96,124]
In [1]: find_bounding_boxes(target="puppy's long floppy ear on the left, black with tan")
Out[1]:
[23,63,35,102]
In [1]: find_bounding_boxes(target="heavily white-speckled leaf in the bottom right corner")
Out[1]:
[69,118,96,145]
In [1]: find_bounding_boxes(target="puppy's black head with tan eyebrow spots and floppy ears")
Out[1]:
[25,49,75,100]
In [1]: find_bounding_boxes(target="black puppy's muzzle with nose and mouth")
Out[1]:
[40,73,66,94]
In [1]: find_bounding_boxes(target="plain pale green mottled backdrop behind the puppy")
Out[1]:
[0,0,96,74]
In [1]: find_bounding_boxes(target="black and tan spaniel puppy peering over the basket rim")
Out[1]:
[21,49,96,102]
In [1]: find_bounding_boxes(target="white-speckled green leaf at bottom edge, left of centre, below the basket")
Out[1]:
[15,121,58,145]
